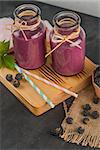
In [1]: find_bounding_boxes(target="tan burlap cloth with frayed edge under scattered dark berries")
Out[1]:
[60,86,100,148]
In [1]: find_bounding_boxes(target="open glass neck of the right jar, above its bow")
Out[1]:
[53,11,80,35]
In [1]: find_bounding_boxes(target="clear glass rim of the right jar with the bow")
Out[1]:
[53,11,81,29]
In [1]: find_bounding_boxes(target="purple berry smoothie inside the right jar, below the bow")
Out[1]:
[50,11,85,76]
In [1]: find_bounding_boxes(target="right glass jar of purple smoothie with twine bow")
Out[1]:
[50,11,86,76]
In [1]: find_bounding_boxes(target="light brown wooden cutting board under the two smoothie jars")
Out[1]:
[0,57,96,116]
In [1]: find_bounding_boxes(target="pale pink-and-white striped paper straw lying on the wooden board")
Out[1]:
[22,69,78,98]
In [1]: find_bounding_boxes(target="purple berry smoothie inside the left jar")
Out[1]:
[13,5,46,69]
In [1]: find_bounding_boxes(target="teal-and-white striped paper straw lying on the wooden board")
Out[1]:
[15,64,55,108]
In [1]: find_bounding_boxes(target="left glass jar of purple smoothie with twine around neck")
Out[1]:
[13,4,46,69]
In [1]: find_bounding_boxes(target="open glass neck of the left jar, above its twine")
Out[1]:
[14,4,41,26]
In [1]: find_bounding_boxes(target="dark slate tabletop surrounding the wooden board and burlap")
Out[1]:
[0,1,100,150]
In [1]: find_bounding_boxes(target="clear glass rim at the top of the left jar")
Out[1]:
[13,4,41,20]
